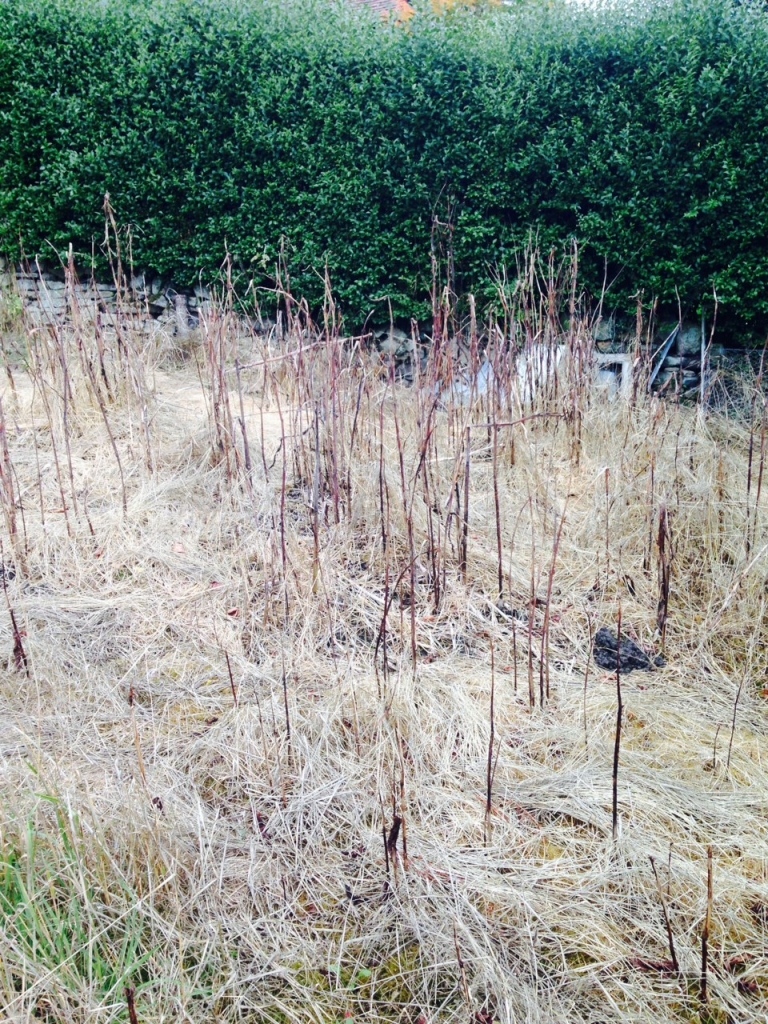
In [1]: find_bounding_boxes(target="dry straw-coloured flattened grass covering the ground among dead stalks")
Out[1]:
[0,299,768,1024]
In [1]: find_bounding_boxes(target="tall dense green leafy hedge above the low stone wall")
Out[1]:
[0,0,768,323]
